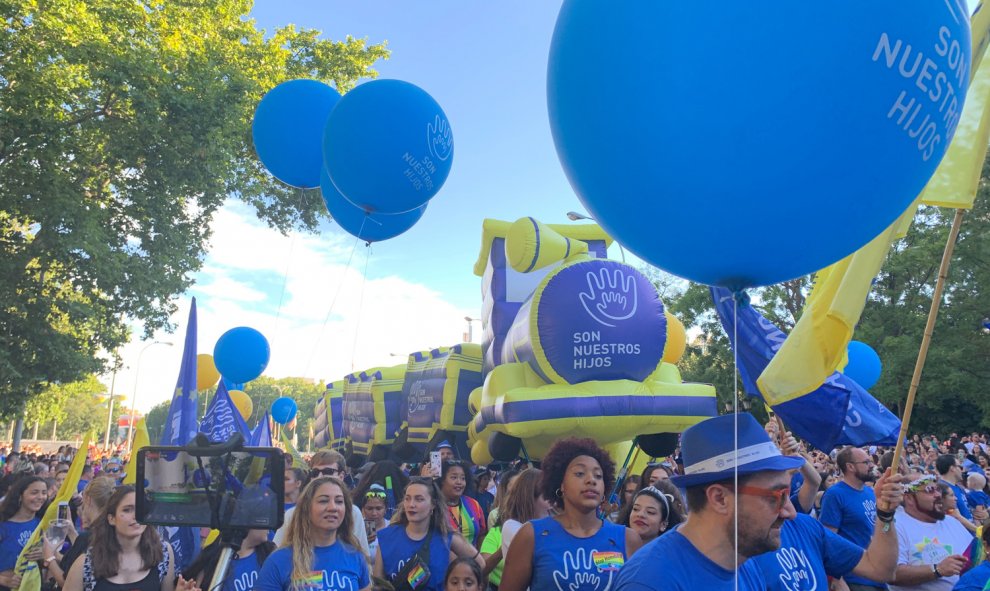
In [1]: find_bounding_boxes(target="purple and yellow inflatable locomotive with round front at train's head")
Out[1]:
[467,218,717,465]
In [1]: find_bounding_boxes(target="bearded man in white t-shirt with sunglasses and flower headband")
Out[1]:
[890,472,975,591]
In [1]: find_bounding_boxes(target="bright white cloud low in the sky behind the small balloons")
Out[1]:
[102,203,480,412]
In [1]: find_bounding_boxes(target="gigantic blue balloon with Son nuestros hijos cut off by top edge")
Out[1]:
[552,0,970,288]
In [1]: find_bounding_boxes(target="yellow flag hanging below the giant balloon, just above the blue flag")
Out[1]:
[756,203,917,406]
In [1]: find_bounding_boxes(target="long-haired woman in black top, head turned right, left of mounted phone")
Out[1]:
[63,486,182,591]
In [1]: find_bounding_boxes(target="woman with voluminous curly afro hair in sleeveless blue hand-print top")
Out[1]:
[499,438,642,591]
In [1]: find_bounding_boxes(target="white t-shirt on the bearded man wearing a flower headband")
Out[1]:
[889,508,976,591]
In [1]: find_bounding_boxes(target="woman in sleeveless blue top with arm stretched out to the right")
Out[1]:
[375,476,484,591]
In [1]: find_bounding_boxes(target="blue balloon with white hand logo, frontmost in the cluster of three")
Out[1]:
[323,80,454,213]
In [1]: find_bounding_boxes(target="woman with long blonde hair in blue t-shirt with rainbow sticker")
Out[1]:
[254,476,371,591]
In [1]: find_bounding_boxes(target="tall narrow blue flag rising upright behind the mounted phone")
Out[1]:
[159,298,200,572]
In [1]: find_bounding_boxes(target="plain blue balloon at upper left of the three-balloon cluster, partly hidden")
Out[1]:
[251,79,340,189]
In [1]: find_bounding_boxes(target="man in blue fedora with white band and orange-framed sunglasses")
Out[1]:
[615,413,805,591]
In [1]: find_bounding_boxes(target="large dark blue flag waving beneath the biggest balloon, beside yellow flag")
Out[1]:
[711,287,901,451]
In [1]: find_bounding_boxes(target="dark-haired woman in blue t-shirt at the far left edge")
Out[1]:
[0,476,48,591]
